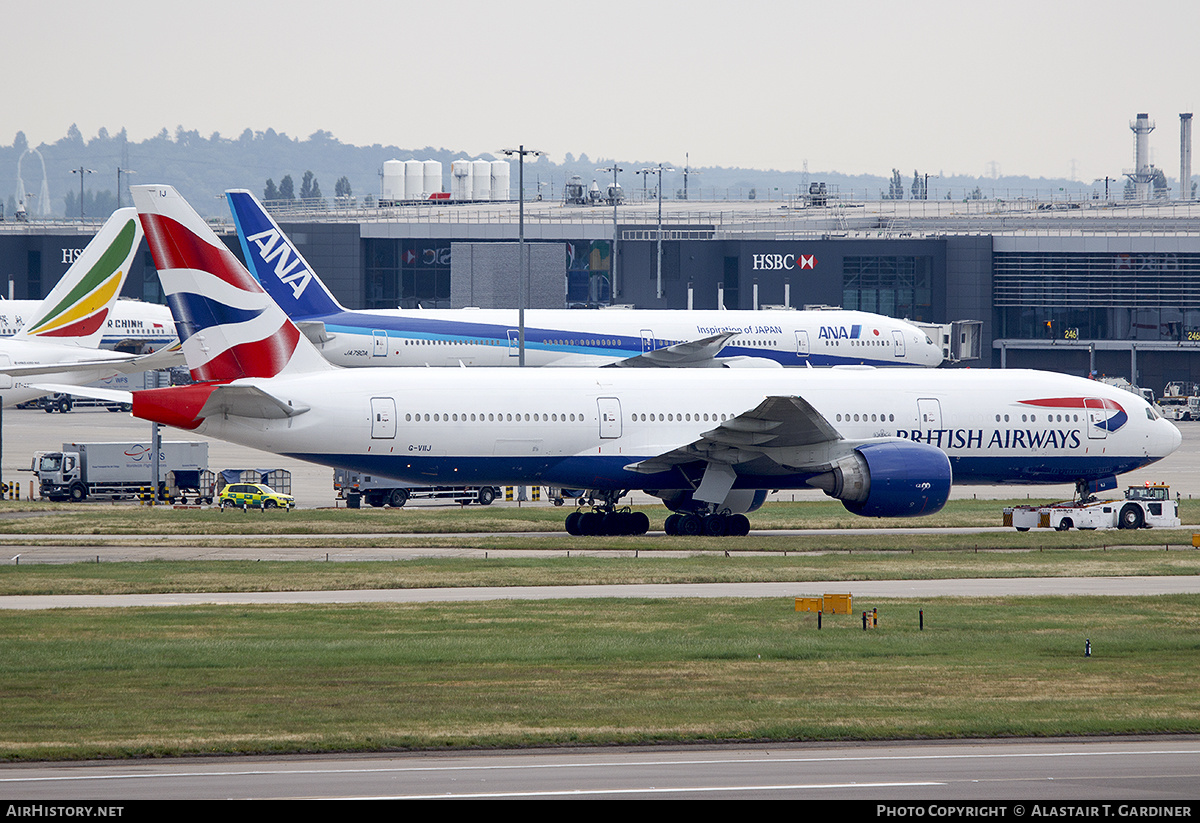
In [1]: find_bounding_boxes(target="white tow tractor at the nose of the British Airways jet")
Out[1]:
[1004,483,1181,531]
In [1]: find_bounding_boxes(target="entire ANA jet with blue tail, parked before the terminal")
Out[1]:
[226,191,943,368]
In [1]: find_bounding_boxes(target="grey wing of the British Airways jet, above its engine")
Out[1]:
[625,396,842,474]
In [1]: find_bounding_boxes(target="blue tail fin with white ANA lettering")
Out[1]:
[226,188,346,320]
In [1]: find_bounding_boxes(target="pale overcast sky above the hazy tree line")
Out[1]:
[11,0,1200,182]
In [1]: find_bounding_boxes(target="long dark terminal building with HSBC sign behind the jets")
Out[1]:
[0,199,1200,394]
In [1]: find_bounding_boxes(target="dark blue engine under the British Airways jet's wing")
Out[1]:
[811,440,952,517]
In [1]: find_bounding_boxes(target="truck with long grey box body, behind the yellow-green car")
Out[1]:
[30,440,211,503]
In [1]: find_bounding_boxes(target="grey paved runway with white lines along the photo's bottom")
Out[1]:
[0,737,1200,801]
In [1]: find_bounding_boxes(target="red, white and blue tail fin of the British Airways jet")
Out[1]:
[130,186,334,382]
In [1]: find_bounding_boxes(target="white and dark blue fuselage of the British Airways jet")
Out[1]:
[169,368,1180,488]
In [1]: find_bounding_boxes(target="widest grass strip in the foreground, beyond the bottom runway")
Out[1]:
[0,596,1200,759]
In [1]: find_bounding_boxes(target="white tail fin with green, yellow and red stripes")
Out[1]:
[16,209,142,349]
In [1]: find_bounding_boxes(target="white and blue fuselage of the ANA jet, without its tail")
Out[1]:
[297,308,942,367]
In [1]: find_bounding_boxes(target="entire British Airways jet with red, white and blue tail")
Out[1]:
[82,186,1182,535]
